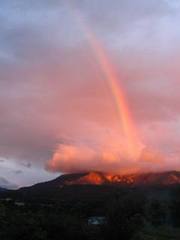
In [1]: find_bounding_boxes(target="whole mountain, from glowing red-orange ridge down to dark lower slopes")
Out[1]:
[0,171,180,204]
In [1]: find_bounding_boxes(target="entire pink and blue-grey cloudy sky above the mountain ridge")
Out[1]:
[0,0,180,188]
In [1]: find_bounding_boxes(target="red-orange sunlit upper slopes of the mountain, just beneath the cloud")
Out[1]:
[23,171,180,188]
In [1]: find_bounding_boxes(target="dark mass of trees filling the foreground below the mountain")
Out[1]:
[0,189,180,240]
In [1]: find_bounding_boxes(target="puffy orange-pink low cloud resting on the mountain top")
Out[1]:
[47,141,168,173]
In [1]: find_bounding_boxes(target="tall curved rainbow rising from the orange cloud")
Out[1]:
[67,3,142,160]
